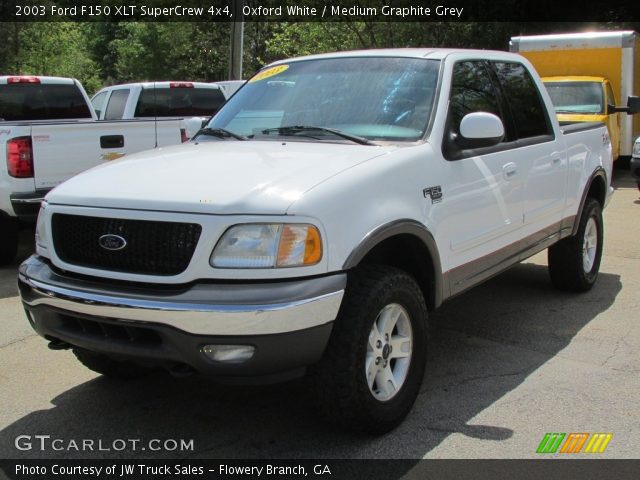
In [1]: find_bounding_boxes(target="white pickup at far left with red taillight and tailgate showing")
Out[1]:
[0,76,186,265]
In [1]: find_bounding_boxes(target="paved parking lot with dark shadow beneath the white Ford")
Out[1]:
[0,172,640,459]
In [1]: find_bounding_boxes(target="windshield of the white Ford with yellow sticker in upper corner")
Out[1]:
[208,57,440,143]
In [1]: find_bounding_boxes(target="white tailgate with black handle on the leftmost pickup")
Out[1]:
[31,120,181,189]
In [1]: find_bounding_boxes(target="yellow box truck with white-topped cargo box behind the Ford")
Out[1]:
[509,31,640,159]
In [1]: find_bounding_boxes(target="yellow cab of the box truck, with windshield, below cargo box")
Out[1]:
[542,76,620,158]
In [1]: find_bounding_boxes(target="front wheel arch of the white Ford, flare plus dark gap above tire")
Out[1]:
[343,219,444,310]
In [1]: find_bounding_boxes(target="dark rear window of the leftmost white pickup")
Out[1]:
[0,83,91,121]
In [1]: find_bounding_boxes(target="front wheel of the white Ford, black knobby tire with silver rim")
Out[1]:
[314,266,427,434]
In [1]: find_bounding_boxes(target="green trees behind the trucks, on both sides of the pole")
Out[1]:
[0,21,640,93]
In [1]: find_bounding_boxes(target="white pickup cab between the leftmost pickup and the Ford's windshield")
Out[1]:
[91,82,230,138]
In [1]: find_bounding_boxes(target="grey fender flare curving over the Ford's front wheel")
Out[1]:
[342,219,444,308]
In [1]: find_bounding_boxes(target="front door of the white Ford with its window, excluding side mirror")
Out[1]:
[442,60,531,294]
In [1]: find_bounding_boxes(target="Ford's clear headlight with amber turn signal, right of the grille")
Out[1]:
[210,223,322,268]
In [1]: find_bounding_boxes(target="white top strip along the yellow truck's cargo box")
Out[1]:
[510,30,638,52]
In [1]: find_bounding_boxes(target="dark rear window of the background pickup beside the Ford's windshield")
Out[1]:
[134,87,225,117]
